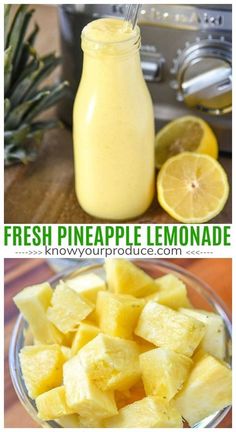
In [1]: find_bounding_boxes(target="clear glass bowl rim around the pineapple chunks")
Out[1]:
[9,259,232,428]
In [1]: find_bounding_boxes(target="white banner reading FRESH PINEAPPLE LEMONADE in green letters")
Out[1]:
[3,224,233,259]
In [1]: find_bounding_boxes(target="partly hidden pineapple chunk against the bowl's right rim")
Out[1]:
[180,309,226,360]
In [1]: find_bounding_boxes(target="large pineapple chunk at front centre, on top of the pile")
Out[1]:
[78,334,141,390]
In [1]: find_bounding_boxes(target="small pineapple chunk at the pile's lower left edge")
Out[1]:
[35,386,75,420]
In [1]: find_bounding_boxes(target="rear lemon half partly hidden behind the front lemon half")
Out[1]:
[155,116,218,168]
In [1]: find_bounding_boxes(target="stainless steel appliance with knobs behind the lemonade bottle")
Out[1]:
[59,4,232,151]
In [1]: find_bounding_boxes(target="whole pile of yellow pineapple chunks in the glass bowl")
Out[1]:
[14,259,232,428]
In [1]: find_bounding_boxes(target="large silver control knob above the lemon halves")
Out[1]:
[171,35,232,115]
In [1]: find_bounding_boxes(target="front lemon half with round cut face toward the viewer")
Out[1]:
[157,152,229,223]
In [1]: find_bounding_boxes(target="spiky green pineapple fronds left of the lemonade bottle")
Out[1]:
[4,5,68,165]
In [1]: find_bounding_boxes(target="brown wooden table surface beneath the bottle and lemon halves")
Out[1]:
[5,5,232,224]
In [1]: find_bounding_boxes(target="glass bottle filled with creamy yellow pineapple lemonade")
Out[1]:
[73,18,154,220]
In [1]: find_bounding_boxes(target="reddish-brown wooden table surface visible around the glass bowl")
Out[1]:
[4,258,232,428]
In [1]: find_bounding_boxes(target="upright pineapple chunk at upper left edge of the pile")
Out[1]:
[13,282,63,344]
